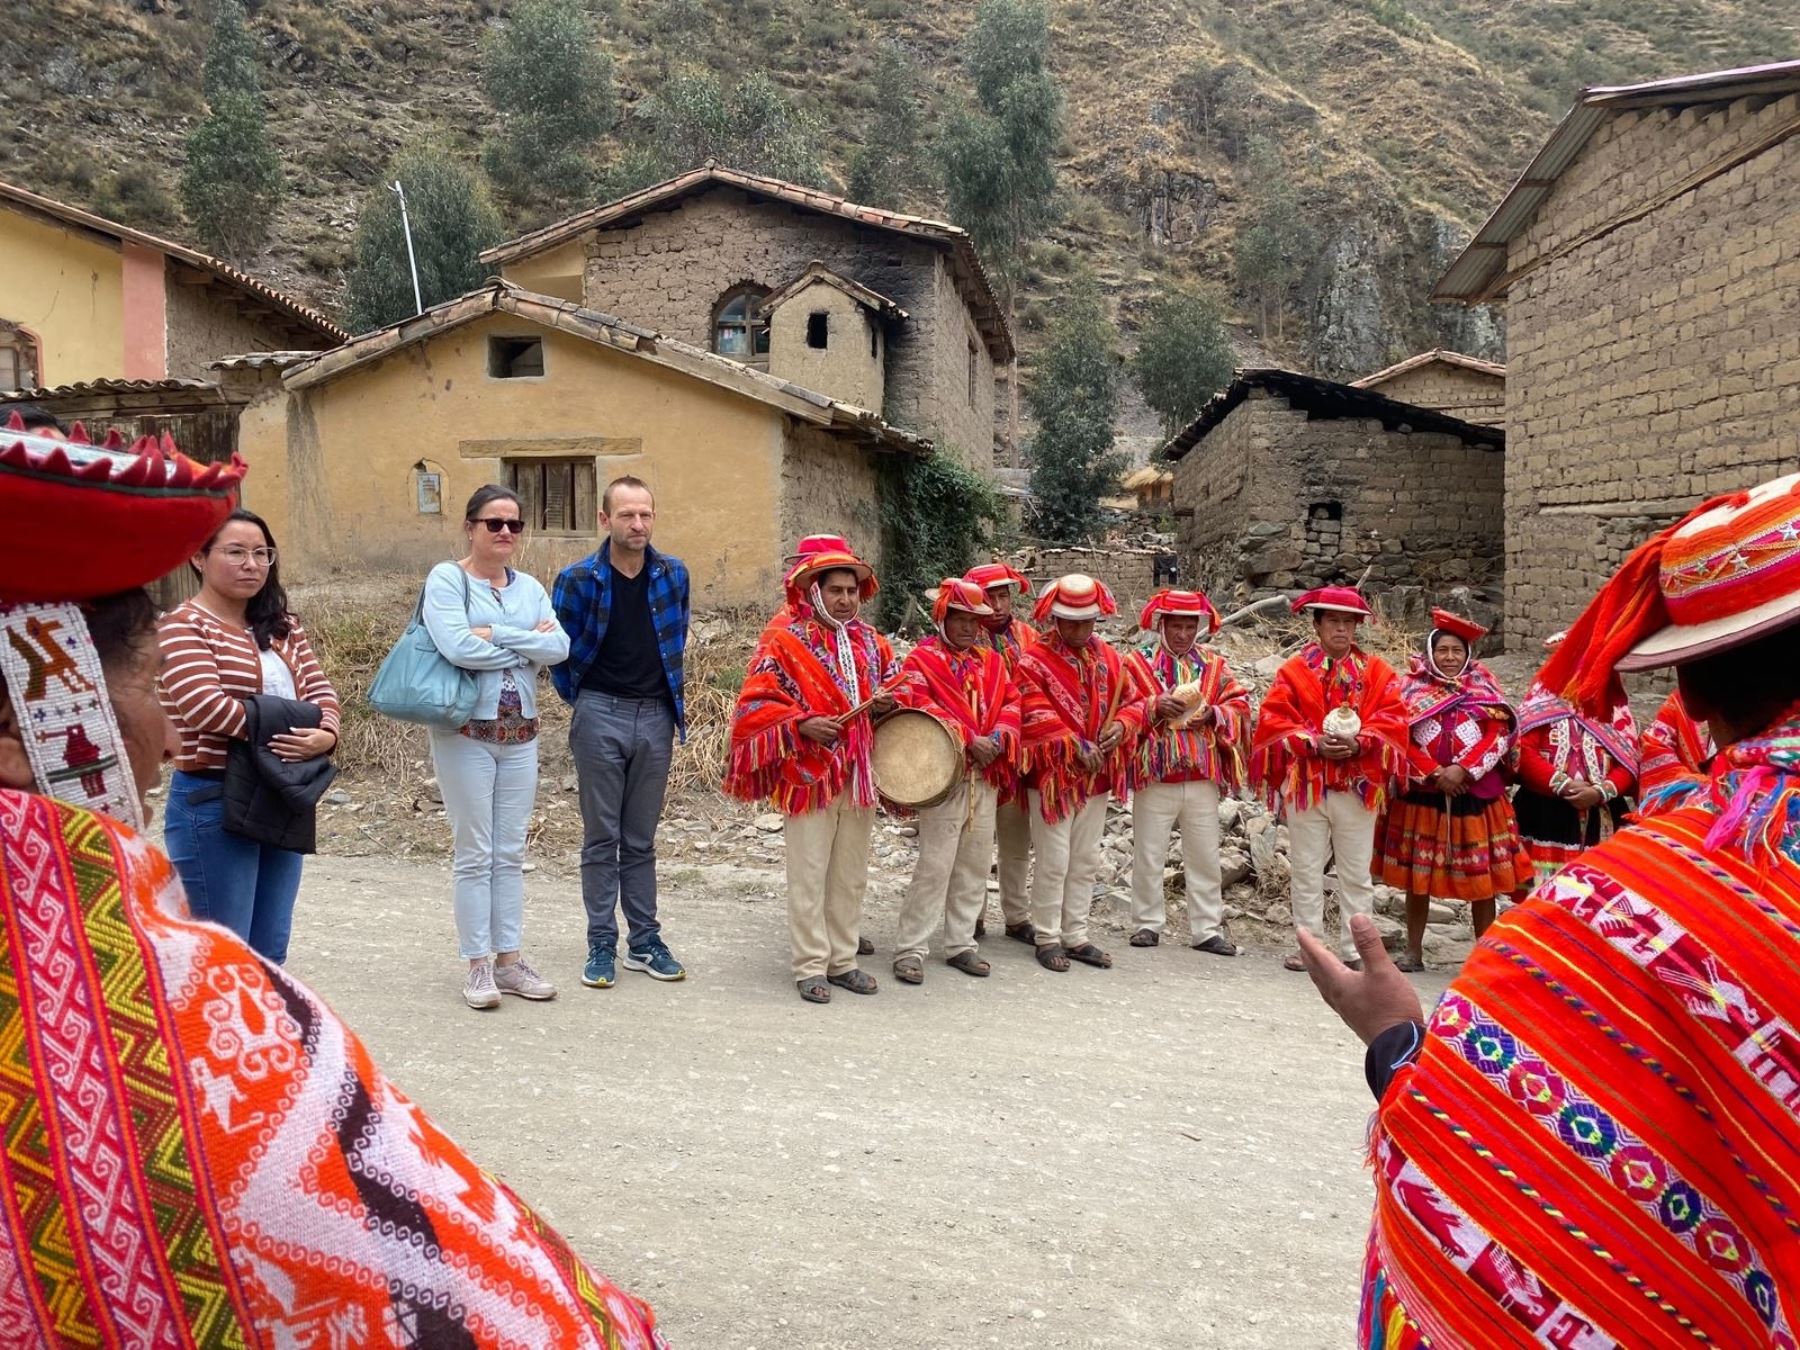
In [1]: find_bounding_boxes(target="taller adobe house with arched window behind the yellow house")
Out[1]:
[481,164,1013,470]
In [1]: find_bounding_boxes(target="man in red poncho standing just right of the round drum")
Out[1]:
[895,576,1019,985]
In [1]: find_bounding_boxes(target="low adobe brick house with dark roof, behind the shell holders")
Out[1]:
[1161,369,1505,617]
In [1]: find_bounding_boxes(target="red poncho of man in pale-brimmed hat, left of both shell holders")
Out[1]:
[1019,635,1143,823]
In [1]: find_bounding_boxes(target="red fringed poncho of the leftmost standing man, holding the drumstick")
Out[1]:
[724,617,895,815]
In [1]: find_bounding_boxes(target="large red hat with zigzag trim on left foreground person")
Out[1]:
[0,423,245,603]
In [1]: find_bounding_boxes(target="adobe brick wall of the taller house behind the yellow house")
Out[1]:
[583,187,994,470]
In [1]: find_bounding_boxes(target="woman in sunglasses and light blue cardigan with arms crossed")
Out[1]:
[425,482,569,1008]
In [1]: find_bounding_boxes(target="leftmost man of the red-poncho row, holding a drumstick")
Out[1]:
[725,549,895,1003]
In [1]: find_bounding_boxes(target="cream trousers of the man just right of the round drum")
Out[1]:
[895,778,997,961]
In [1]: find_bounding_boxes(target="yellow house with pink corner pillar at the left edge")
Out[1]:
[0,182,349,391]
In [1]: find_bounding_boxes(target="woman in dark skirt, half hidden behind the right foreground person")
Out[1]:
[1512,634,1638,895]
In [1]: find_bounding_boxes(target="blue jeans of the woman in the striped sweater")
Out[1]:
[162,770,302,965]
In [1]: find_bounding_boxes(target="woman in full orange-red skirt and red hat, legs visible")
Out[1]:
[1375,610,1532,970]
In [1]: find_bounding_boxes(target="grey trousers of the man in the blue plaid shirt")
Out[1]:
[569,689,675,950]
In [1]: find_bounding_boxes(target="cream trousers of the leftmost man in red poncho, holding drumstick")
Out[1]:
[781,792,875,979]
